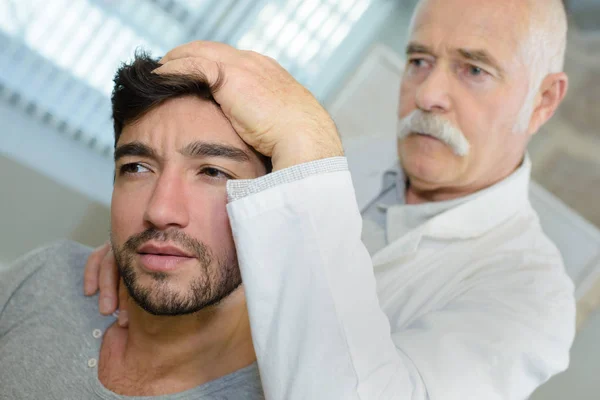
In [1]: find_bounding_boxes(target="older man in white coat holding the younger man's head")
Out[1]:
[88,0,575,400]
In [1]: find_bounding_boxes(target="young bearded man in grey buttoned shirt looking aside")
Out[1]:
[0,55,270,400]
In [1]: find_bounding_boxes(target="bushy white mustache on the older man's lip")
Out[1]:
[398,110,471,157]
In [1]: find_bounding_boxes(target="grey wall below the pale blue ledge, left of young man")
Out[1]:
[0,156,110,265]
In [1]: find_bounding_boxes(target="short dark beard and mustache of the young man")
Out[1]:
[111,228,242,316]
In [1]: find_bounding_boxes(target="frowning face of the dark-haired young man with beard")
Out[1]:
[111,97,266,315]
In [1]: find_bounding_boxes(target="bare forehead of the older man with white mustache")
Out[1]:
[409,0,529,66]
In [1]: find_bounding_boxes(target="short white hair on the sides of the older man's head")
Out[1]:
[409,0,567,133]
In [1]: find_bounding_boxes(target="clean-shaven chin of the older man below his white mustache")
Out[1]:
[398,134,467,185]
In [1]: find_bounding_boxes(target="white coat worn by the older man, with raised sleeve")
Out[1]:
[228,158,575,400]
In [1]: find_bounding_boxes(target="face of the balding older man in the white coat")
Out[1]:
[398,0,529,190]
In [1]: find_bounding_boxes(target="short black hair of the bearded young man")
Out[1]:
[111,51,273,173]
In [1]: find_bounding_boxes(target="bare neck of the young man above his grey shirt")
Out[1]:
[103,288,256,395]
